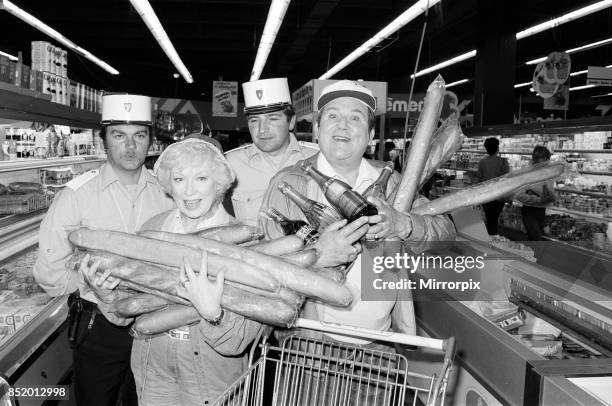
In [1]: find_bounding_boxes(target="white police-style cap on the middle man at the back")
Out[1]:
[242,78,291,115]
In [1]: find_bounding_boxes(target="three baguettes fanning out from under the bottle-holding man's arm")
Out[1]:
[389,75,566,216]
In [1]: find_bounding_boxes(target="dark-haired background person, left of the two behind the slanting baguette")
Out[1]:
[476,137,510,235]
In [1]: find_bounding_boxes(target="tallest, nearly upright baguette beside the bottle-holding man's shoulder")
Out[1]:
[393,75,446,212]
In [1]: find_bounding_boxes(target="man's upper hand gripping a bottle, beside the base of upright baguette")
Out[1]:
[366,196,412,240]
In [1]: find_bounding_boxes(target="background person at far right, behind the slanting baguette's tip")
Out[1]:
[514,145,557,241]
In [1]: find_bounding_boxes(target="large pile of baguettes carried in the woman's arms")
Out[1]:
[69,225,352,335]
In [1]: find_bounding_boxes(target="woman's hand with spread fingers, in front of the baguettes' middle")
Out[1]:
[179,251,225,320]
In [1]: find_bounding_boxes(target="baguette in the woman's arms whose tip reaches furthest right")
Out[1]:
[143,231,352,306]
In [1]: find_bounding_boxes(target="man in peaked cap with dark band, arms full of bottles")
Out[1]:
[262,80,455,345]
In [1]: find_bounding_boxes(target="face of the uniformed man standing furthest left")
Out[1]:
[104,124,149,172]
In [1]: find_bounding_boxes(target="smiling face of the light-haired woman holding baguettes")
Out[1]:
[170,164,220,219]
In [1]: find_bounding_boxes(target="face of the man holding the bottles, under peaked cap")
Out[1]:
[314,97,374,167]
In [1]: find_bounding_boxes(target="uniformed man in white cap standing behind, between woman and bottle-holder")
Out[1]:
[226,78,318,225]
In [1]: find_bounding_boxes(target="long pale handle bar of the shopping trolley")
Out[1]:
[293,318,444,351]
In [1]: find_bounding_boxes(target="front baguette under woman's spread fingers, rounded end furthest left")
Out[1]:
[68,227,279,291]
